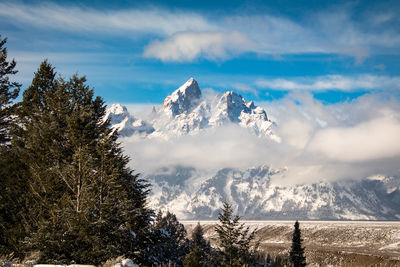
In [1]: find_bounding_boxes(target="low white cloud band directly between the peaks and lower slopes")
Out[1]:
[122,125,272,172]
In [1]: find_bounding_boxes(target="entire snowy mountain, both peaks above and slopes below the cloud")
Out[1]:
[105,78,400,220]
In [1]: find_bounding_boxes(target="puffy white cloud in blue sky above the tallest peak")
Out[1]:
[144,32,254,62]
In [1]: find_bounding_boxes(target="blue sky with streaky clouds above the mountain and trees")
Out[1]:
[0,1,400,103]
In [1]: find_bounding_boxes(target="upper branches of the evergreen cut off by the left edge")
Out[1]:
[0,35,21,146]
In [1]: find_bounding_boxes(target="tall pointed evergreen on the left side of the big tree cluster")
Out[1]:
[12,61,62,237]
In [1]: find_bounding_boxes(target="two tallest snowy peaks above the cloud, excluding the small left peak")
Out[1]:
[155,78,279,140]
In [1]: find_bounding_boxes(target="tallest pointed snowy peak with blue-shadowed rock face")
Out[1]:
[162,78,201,117]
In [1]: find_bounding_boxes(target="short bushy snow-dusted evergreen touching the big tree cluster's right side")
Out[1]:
[153,211,190,266]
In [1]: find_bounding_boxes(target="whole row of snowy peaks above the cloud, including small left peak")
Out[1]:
[106,78,280,142]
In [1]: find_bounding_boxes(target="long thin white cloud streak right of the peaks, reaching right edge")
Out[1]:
[256,74,400,91]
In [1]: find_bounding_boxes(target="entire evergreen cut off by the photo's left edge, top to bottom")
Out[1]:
[0,35,27,257]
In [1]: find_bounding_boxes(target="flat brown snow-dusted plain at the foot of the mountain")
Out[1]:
[182,221,400,266]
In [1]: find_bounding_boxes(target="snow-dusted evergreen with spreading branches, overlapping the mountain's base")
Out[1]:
[215,202,258,266]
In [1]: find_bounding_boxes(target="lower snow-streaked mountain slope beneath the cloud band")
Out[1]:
[146,166,400,220]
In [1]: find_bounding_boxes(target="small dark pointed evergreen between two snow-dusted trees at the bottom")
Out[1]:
[183,223,215,267]
